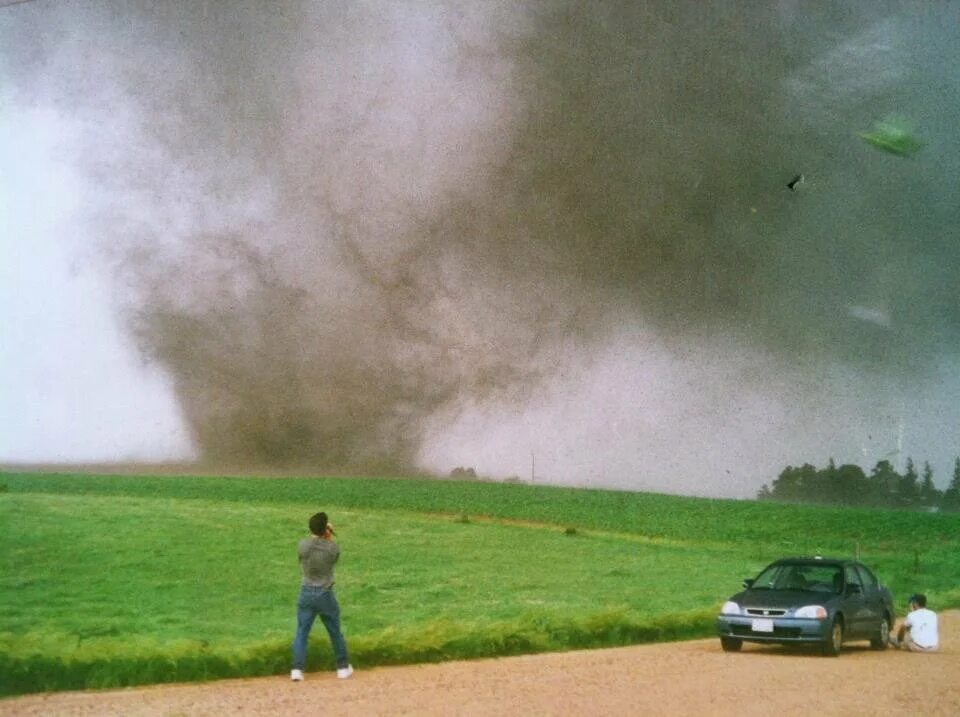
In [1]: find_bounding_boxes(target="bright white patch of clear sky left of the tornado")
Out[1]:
[0,99,194,463]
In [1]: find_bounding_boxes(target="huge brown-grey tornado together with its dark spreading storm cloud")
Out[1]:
[3,2,960,482]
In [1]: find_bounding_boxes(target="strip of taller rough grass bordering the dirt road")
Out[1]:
[0,609,716,697]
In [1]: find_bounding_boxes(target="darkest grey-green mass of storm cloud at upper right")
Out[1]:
[464,3,960,370]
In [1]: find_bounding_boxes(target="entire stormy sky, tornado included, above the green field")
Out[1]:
[0,0,960,497]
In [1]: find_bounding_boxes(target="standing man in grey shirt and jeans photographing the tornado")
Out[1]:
[290,513,353,682]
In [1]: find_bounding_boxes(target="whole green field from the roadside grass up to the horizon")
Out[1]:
[0,473,960,695]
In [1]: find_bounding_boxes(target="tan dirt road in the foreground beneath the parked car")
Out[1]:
[0,611,960,717]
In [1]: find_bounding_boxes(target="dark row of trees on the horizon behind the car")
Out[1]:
[757,458,960,511]
